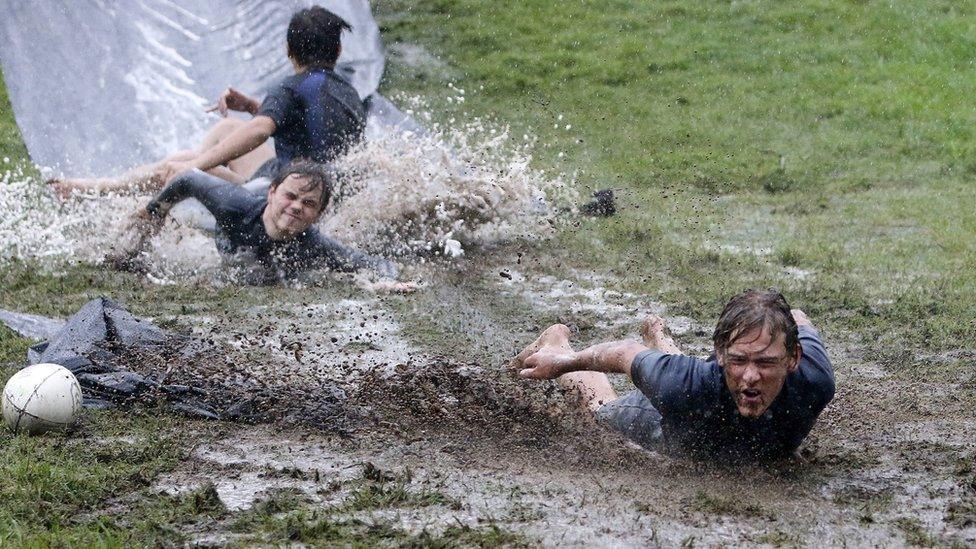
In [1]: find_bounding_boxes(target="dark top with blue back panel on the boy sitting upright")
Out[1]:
[258,69,366,166]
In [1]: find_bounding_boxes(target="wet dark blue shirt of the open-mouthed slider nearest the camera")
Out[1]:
[631,326,834,460]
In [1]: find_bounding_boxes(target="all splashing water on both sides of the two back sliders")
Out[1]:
[0,96,577,283]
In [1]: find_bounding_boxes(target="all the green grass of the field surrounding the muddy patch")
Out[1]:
[0,0,976,545]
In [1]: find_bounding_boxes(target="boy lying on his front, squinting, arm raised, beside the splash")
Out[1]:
[107,162,415,292]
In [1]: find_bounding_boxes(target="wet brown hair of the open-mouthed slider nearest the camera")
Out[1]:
[712,290,800,356]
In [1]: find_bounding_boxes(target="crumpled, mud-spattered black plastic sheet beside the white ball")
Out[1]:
[0,298,346,431]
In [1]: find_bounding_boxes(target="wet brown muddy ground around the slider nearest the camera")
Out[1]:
[95,249,976,546]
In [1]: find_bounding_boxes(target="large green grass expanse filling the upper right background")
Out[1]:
[377,0,976,351]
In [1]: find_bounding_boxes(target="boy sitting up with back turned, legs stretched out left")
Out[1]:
[48,6,366,198]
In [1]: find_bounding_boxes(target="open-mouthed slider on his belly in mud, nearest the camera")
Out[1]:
[512,291,834,461]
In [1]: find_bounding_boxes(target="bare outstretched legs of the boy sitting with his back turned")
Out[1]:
[48,118,274,198]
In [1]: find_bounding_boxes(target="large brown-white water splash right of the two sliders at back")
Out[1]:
[322,98,577,257]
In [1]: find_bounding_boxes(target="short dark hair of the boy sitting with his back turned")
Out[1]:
[287,6,352,67]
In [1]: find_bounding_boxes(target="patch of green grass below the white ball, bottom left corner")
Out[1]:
[0,412,210,547]
